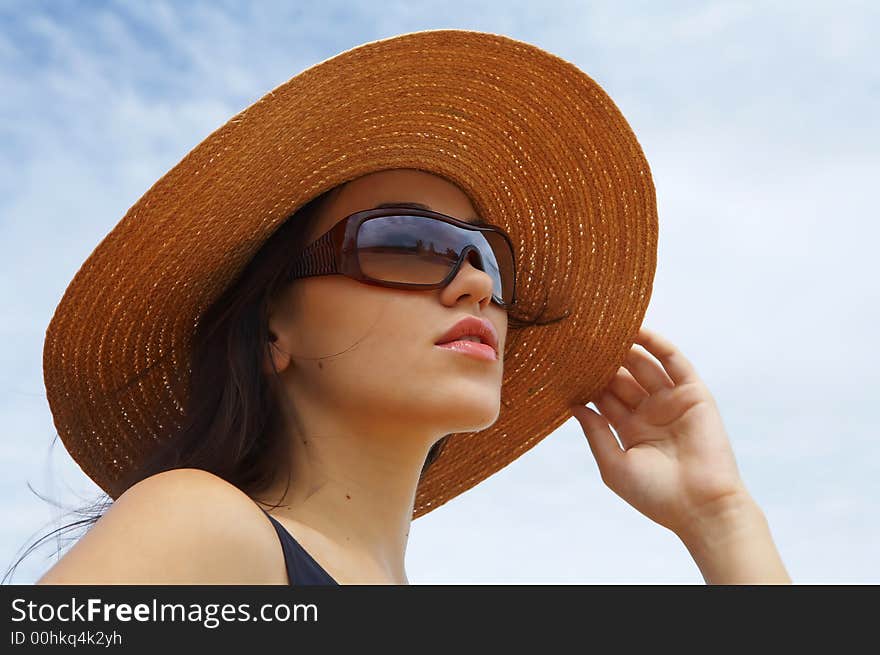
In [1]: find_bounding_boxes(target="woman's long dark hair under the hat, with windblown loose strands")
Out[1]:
[0,184,568,582]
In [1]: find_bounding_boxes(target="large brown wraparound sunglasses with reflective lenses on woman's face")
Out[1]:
[288,208,516,309]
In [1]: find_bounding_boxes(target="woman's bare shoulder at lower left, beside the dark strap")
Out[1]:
[37,468,287,585]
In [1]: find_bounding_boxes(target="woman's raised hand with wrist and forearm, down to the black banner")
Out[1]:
[572,327,791,584]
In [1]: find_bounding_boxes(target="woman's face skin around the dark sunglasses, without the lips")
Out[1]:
[269,169,507,447]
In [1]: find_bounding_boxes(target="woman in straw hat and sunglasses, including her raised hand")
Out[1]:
[15,30,789,584]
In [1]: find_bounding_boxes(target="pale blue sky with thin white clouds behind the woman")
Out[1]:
[0,0,880,584]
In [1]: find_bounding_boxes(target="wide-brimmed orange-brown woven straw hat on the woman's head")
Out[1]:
[43,29,658,518]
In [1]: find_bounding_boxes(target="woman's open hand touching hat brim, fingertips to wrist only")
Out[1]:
[572,327,749,535]
